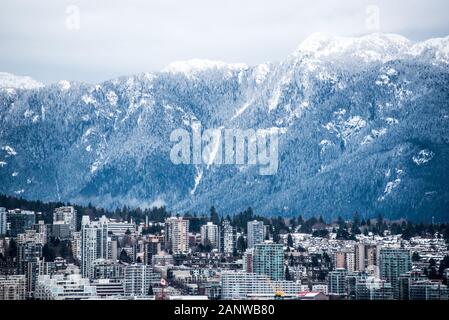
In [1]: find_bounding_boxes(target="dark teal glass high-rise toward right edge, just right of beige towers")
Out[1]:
[379,248,412,299]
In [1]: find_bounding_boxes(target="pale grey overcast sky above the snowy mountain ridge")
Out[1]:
[0,0,449,83]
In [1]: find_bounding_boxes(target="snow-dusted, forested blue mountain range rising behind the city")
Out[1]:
[0,34,449,219]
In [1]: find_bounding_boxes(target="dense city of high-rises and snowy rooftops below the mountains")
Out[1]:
[0,194,449,301]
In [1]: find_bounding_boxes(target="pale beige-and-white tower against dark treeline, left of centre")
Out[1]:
[165,217,189,253]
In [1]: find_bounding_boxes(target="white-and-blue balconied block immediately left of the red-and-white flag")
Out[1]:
[123,264,161,297]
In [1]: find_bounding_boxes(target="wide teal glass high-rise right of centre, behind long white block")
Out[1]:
[253,242,285,281]
